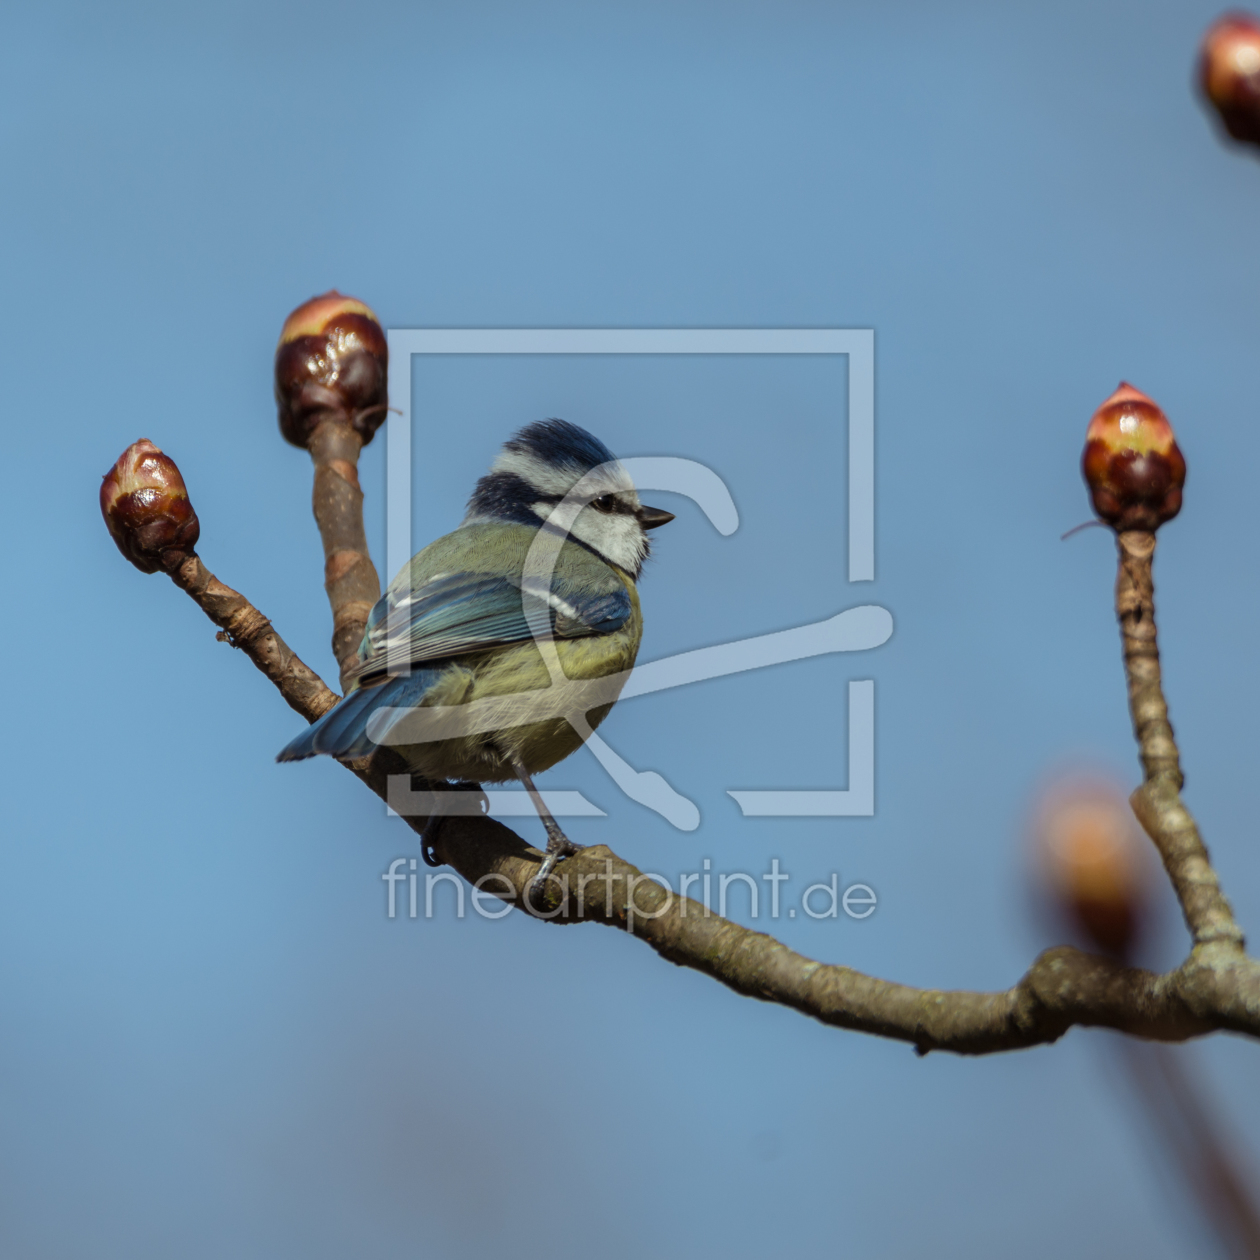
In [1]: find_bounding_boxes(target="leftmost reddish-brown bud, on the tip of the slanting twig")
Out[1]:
[101,437,202,573]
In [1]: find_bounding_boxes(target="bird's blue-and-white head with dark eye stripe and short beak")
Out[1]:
[464,420,674,578]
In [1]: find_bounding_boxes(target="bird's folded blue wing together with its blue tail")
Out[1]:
[276,573,631,761]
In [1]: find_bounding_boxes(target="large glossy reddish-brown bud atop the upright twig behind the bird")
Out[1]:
[276,289,389,447]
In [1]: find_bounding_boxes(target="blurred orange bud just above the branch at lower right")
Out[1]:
[1036,779,1150,958]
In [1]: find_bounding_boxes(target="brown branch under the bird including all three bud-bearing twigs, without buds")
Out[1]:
[103,425,1260,1055]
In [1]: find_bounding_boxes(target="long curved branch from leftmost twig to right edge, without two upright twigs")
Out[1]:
[154,531,1260,1055]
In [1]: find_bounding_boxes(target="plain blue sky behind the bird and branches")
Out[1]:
[0,3,1260,1260]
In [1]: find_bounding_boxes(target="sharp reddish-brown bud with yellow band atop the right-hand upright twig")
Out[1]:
[1081,381,1186,530]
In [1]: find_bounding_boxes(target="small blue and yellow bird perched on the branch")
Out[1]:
[276,418,674,888]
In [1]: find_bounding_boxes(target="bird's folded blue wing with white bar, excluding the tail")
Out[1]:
[355,573,631,678]
